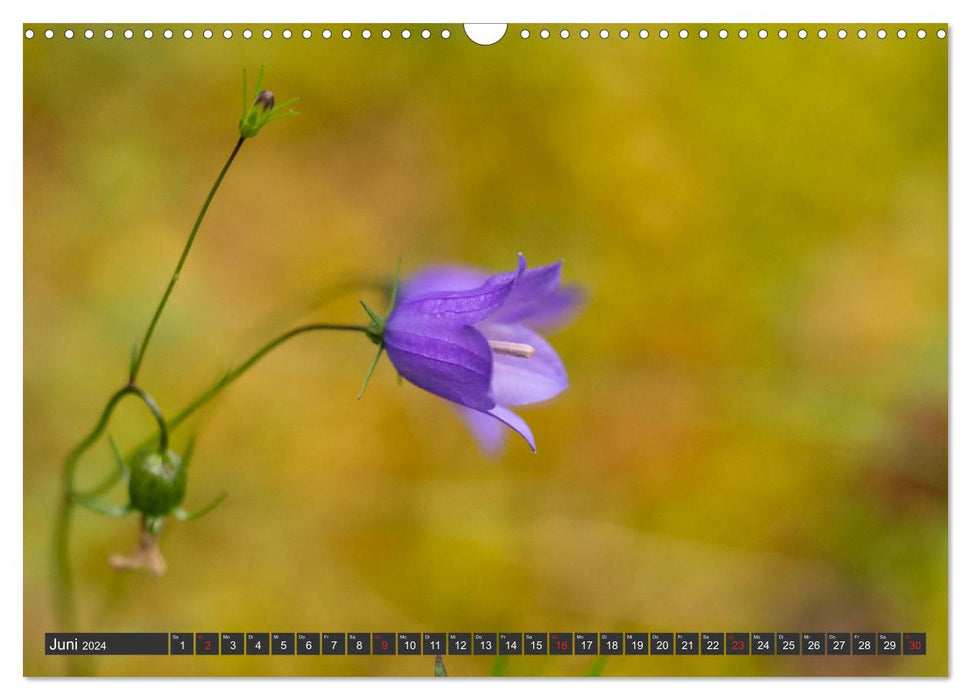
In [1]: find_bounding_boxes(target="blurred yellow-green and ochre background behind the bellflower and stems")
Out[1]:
[24,25,948,676]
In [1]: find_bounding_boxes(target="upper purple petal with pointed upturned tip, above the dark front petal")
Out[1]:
[388,255,526,326]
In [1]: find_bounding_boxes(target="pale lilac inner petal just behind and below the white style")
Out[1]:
[479,326,569,406]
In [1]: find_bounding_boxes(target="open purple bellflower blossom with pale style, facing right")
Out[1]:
[365,254,581,452]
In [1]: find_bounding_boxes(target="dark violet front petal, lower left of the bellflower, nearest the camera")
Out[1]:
[384,316,495,410]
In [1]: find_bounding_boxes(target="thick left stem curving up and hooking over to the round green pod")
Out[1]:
[52,384,168,632]
